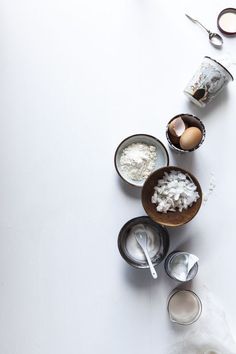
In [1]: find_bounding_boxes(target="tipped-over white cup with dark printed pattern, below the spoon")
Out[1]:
[184,56,234,107]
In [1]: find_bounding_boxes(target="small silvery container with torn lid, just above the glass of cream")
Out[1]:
[165,251,198,282]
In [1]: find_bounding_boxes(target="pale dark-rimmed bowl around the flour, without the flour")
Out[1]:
[114,134,169,187]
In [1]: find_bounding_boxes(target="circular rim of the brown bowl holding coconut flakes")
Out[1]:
[141,165,203,228]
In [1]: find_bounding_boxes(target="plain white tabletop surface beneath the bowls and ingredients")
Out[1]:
[0,0,236,354]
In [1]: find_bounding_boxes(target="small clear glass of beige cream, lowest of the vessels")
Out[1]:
[167,290,202,325]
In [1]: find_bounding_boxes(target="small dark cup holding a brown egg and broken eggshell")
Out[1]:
[166,113,206,152]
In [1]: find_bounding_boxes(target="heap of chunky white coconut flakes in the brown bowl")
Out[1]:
[152,171,199,213]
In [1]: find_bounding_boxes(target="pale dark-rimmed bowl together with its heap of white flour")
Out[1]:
[114,134,169,187]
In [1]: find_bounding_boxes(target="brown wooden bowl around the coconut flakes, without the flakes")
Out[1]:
[142,166,202,227]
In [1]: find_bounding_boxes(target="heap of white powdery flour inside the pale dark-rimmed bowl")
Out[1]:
[120,143,157,181]
